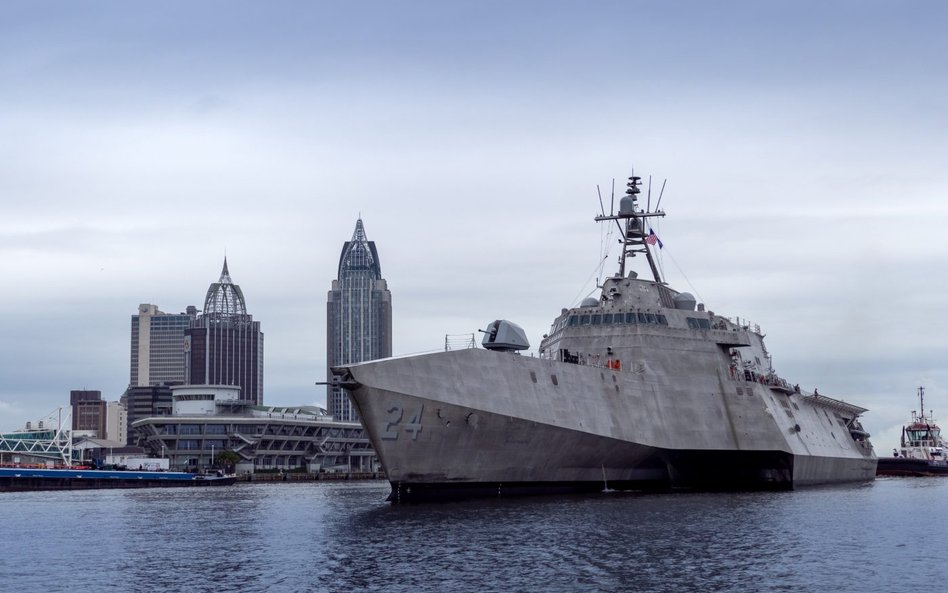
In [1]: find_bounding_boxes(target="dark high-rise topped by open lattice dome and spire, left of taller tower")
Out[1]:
[185,258,263,405]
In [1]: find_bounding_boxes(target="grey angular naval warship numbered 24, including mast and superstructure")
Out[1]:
[332,175,877,502]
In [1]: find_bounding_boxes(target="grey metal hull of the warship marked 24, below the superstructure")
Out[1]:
[335,349,876,501]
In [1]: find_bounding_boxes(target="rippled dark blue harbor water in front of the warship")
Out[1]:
[0,478,948,593]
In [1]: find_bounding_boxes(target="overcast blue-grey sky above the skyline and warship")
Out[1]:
[0,0,948,454]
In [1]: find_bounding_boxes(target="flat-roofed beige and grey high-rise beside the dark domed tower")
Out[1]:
[129,303,197,387]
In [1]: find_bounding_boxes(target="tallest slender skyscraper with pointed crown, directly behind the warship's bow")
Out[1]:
[326,218,392,422]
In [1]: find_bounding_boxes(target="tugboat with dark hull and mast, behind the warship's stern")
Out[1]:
[876,387,948,476]
